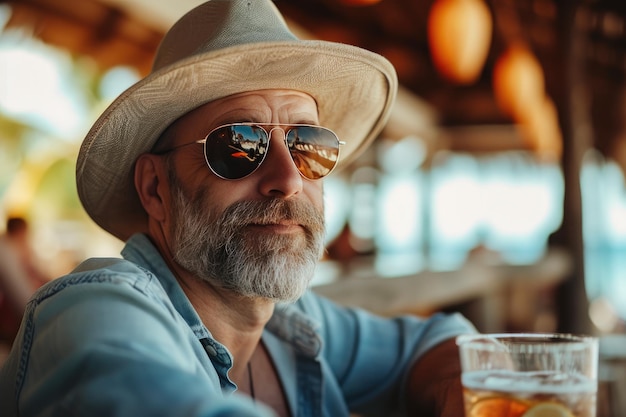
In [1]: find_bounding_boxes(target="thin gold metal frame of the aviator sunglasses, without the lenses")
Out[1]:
[158,122,346,181]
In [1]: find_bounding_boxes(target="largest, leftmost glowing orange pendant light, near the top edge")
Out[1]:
[427,0,493,84]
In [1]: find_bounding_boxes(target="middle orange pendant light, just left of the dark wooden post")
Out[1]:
[492,43,545,121]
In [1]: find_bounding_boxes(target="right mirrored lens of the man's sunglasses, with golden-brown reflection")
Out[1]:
[287,126,339,180]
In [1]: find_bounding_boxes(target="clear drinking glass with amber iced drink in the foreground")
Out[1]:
[457,333,598,417]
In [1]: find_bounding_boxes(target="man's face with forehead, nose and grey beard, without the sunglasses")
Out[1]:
[158,90,324,301]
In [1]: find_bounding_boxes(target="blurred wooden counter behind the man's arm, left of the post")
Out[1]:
[312,245,571,331]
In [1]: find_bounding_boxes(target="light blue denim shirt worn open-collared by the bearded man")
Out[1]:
[0,235,475,417]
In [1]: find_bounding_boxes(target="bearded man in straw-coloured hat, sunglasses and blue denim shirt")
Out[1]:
[0,0,473,417]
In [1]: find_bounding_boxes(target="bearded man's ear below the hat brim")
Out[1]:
[135,154,167,221]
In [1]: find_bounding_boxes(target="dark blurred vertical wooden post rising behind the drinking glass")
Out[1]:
[548,0,594,334]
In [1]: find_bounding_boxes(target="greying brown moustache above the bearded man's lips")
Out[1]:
[217,199,324,232]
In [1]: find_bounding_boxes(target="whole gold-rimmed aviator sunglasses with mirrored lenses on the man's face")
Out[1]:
[158,123,345,180]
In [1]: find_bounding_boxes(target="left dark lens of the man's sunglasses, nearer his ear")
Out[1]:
[204,125,268,180]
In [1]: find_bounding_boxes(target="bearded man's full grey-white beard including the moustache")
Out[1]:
[170,181,325,301]
